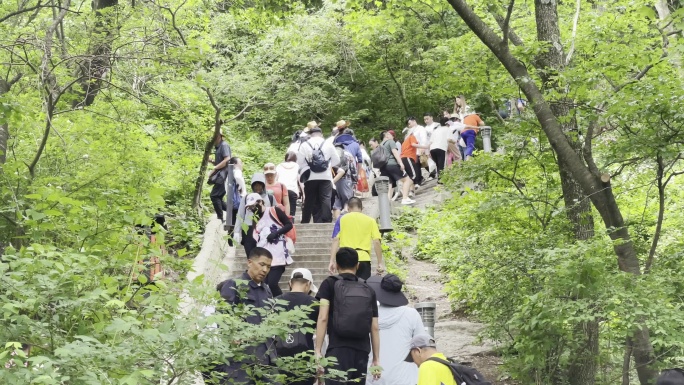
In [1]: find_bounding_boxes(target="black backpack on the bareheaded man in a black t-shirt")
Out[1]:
[332,275,374,339]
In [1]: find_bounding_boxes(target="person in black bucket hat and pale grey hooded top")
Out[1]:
[366,274,425,385]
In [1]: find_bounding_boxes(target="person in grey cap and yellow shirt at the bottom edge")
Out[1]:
[406,334,458,385]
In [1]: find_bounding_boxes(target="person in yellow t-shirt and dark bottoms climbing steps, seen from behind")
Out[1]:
[328,197,385,280]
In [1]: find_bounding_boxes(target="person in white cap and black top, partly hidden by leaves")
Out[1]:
[276,268,318,385]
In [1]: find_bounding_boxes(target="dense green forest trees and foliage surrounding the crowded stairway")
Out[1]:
[0,0,684,385]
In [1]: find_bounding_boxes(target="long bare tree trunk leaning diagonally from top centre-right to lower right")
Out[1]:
[448,0,656,385]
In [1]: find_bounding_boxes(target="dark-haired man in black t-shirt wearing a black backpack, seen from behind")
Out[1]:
[316,247,380,385]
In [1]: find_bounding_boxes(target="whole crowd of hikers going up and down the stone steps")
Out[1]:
[203,100,684,385]
